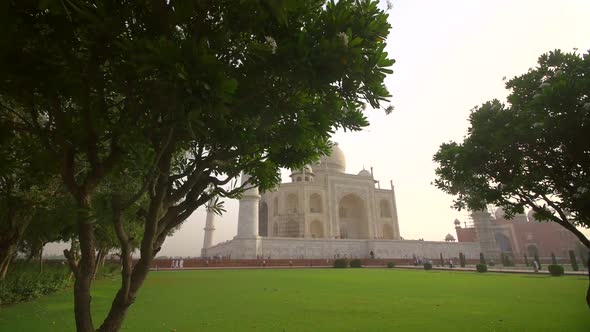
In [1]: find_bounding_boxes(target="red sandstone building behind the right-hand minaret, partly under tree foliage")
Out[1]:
[455,208,579,258]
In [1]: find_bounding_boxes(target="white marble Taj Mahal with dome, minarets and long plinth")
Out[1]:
[201,144,499,259]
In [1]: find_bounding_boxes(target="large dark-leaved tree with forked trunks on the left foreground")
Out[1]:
[0,0,393,331]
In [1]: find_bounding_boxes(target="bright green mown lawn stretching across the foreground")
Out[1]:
[0,269,590,332]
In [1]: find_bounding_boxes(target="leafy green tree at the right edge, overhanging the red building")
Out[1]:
[434,50,590,305]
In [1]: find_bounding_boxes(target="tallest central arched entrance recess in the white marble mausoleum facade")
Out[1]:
[338,194,369,239]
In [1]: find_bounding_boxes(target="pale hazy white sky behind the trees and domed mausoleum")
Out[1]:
[46,0,590,256]
